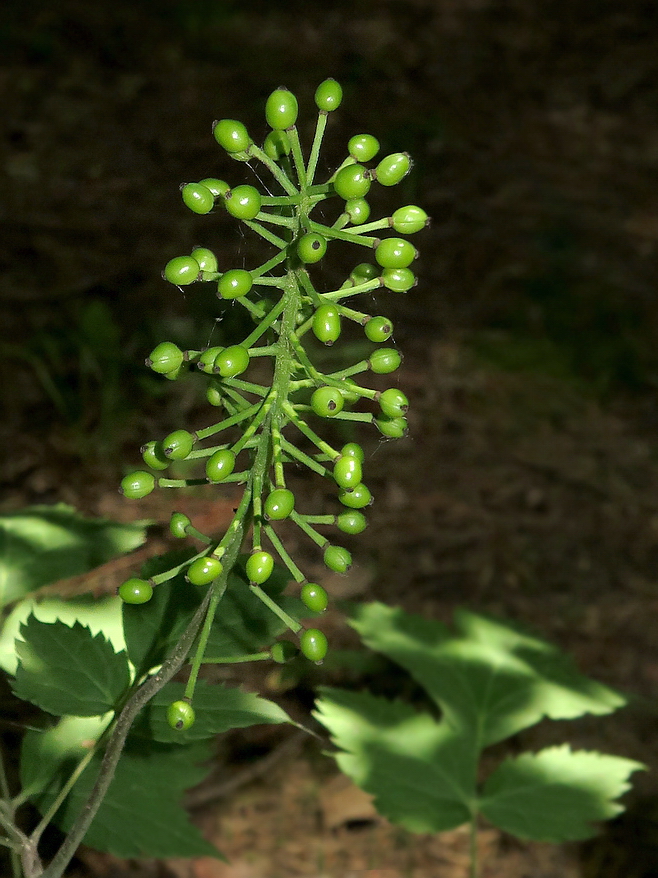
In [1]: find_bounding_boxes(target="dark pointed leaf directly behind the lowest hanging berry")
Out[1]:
[131,680,291,744]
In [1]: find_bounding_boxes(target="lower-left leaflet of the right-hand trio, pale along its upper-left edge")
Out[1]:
[314,687,475,833]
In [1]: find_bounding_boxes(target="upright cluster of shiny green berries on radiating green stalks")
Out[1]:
[119,79,429,700]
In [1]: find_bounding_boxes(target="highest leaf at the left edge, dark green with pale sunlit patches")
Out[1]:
[0,504,147,608]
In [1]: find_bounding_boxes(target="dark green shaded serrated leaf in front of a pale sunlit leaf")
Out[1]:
[13,616,130,716]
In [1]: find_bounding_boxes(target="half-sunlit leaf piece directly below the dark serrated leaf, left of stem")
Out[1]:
[20,714,113,798]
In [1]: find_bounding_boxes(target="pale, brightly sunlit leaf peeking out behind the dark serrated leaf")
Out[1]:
[0,595,126,675]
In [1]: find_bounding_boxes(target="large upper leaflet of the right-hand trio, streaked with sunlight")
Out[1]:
[350,603,625,747]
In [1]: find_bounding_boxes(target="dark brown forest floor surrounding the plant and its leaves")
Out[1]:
[0,0,658,878]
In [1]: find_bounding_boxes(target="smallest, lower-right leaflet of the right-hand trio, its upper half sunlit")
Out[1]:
[480,744,646,842]
